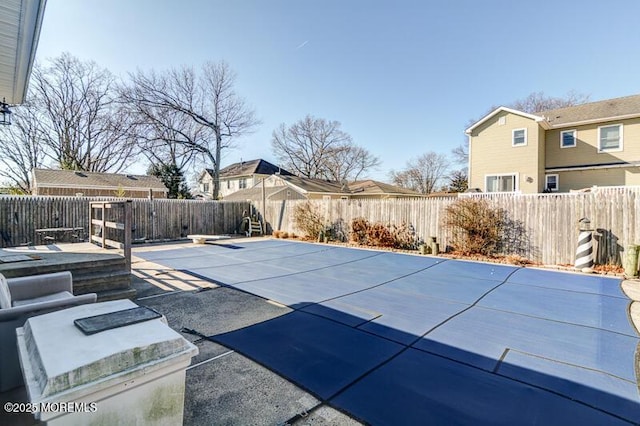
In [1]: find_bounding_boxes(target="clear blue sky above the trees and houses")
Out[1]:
[37,0,640,180]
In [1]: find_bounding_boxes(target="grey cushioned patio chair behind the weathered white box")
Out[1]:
[0,272,97,392]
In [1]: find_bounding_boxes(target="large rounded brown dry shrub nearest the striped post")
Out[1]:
[443,198,505,255]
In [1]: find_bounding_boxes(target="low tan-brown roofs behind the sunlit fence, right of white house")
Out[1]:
[225,175,424,201]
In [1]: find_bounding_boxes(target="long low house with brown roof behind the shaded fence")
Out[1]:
[33,169,169,198]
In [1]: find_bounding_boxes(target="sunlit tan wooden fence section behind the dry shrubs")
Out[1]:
[256,188,640,264]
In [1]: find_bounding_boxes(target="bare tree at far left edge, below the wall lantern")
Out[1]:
[0,103,45,194]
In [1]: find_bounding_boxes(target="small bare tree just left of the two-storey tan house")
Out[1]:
[390,151,449,194]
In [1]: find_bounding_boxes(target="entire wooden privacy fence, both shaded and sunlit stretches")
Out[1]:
[0,188,640,264]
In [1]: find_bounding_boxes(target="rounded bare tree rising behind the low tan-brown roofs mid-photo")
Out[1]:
[271,115,380,181]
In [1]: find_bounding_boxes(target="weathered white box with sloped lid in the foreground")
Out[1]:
[17,300,198,425]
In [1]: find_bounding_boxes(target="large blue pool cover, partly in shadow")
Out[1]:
[137,240,640,425]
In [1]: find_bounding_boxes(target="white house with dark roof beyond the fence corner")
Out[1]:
[198,159,291,200]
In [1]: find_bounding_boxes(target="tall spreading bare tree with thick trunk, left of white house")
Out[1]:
[123,62,259,198]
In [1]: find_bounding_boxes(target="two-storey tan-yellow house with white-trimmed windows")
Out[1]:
[466,95,640,193]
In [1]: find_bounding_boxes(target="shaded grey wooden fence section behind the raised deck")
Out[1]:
[0,196,250,247]
